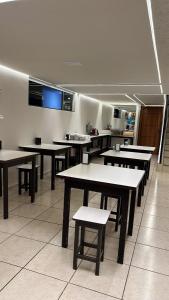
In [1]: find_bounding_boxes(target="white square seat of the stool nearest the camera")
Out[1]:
[73,206,110,225]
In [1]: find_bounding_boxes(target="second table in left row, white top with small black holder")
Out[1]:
[19,144,71,190]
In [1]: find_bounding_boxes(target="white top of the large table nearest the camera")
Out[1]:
[57,164,145,188]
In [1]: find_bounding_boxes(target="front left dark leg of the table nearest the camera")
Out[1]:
[62,180,71,248]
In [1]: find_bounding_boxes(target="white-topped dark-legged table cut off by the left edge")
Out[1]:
[0,149,38,219]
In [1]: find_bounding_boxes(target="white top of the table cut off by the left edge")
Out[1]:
[0,149,38,162]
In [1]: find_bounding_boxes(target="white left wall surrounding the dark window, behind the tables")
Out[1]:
[0,69,112,182]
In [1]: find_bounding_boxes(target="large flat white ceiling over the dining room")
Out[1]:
[0,0,166,104]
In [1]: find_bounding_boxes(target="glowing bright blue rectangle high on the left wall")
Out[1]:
[42,86,63,110]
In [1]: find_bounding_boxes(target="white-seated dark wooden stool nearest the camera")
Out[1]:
[73,206,110,275]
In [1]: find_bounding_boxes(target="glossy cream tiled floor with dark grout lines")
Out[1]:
[0,159,169,300]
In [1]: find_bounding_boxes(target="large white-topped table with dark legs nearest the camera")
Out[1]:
[57,163,145,264]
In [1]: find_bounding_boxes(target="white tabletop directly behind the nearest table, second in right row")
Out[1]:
[100,150,152,161]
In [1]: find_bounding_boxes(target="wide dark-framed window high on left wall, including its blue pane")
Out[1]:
[29,81,73,111]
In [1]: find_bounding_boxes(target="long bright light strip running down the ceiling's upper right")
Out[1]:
[147,0,163,94]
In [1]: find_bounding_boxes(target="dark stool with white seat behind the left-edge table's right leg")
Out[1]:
[18,164,39,195]
